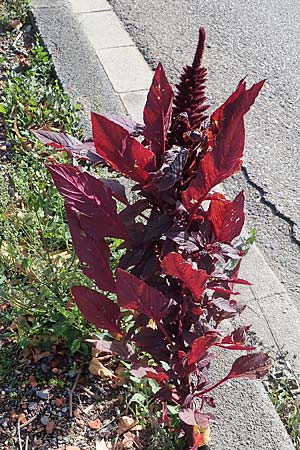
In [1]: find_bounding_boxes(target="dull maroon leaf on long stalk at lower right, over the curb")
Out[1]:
[226,353,272,380]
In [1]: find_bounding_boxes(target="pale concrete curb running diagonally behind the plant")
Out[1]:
[32,0,300,450]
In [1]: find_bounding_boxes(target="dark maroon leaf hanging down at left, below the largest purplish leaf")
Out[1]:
[66,204,116,292]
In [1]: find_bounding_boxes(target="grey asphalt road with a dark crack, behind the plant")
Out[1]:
[110,0,300,302]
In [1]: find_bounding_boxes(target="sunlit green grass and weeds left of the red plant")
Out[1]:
[0,2,95,352]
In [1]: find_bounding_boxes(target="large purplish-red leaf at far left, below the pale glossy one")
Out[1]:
[47,164,127,239]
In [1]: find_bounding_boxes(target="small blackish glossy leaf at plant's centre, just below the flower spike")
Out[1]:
[146,146,189,192]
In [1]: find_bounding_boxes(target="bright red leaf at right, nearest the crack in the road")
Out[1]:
[208,191,245,243]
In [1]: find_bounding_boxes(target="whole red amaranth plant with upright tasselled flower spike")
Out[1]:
[35,28,271,450]
